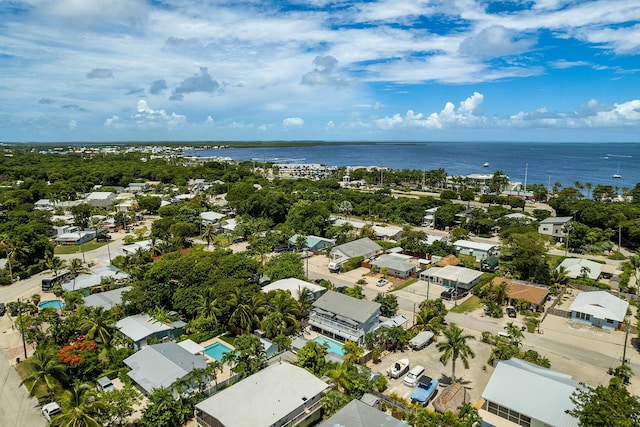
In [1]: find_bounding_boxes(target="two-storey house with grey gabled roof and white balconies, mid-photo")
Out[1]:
[309,291,380,345]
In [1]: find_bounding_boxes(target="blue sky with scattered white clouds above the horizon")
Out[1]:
[0,0,640,142]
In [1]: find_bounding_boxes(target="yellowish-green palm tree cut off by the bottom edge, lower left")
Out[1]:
[54,382,103,427]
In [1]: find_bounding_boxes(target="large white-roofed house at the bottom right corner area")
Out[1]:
[480,359,584,427]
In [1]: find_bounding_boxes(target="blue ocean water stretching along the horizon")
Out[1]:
[185,142,640,188]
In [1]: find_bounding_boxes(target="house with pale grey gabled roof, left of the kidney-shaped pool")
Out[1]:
[123,342,207,398]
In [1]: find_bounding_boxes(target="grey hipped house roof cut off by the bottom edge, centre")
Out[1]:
[318,399,407,427]
